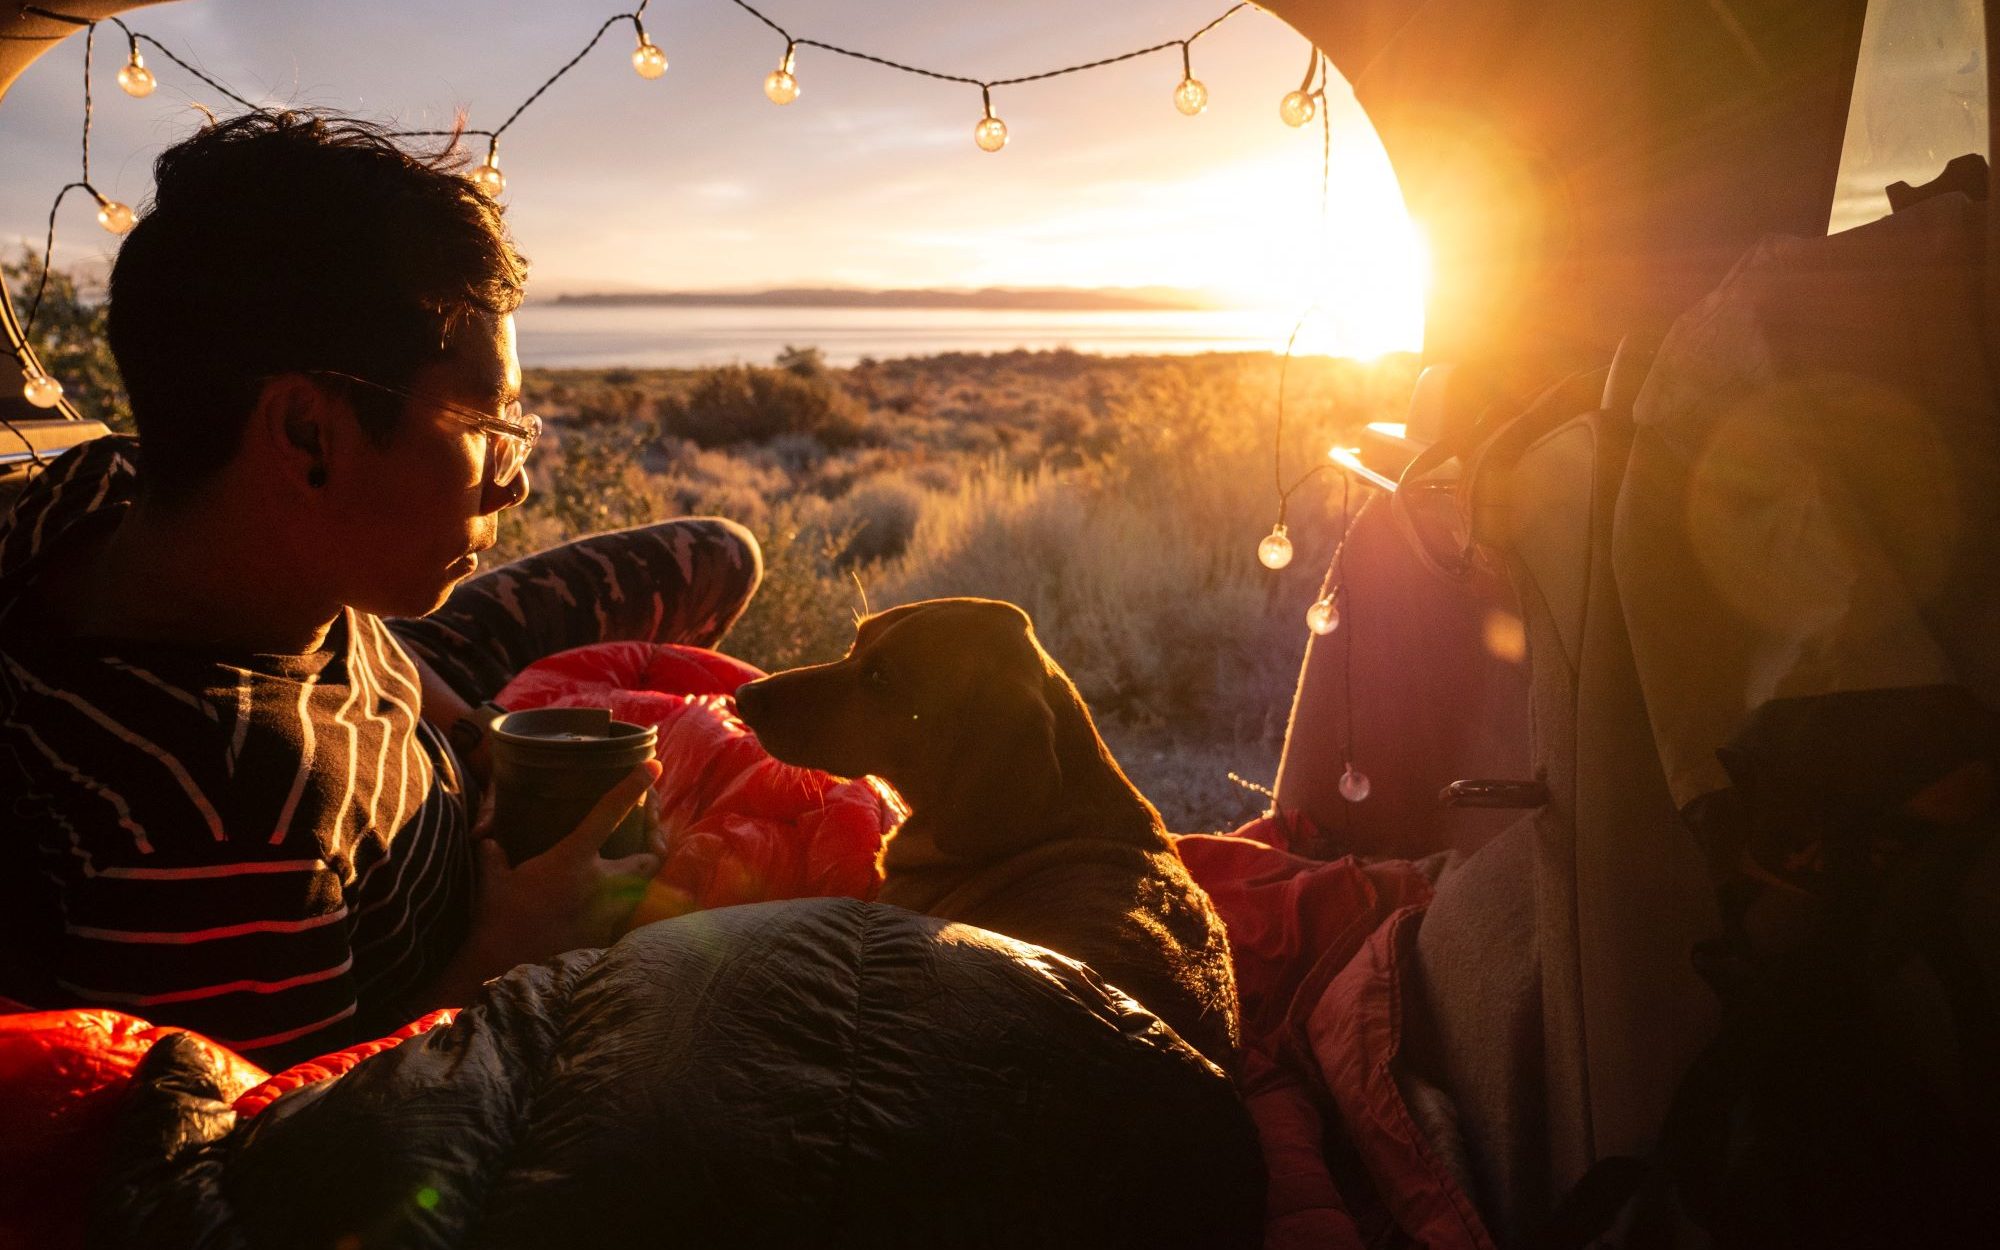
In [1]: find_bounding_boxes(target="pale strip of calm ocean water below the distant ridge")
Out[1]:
[514,304,1292,368]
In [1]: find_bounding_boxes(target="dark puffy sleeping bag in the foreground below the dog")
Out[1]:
[92,898,1264,1250]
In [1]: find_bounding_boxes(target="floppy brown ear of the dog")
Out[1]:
[930,674,1062,862]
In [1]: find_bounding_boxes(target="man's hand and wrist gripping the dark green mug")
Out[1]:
[420,760,666,1010]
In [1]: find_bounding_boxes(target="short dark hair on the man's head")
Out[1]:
[108,112,528,494]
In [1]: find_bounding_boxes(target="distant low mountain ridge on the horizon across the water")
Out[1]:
[548,286,1222,312]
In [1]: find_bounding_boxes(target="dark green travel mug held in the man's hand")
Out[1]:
[488,708,660,864]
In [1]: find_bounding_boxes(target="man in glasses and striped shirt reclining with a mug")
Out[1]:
[0,114,760,1066]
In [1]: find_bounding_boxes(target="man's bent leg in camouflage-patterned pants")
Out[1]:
[388,516,764,704]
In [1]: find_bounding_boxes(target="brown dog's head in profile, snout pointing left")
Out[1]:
[736,598,1096,860]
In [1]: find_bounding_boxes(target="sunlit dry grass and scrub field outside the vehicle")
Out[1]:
[506,352,1412,830]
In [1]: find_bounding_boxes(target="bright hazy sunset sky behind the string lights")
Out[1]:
[0,0,1422,350]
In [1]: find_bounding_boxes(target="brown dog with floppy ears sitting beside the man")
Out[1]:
[736,598,1238,1070]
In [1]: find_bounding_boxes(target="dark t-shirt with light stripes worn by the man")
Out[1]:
[0,438,472,1066]
